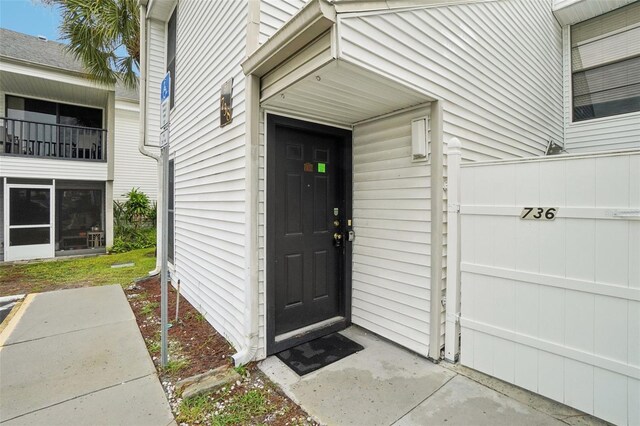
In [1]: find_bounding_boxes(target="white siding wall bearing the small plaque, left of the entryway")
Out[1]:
[165,1,247,349]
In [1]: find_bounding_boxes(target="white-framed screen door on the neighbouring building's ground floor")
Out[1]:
[4,183,55,260]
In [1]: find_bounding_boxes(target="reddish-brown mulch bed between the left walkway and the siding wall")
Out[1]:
[125,277,317,426]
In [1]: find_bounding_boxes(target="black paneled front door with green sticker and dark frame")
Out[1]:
[267,116,351,351]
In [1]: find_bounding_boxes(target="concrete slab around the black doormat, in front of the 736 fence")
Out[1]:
[260,327,604,426]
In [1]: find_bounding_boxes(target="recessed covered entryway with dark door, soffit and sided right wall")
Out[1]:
[248,34,443,358]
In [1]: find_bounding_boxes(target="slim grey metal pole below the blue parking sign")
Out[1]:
[160,144,169,368]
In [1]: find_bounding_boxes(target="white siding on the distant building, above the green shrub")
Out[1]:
[113,105,158,200]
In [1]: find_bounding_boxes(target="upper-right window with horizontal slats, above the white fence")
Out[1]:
[571,2,640,121]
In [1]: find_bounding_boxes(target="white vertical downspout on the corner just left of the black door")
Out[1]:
[232,0,260,366]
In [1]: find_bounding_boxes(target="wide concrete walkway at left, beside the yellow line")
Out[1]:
[0,285,175,426]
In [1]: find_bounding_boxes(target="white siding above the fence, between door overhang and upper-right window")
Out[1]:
[339,0,563,160]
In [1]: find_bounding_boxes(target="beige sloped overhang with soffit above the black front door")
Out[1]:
[242,0,436,127]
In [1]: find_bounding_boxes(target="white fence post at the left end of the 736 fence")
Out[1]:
[444,138,462,362]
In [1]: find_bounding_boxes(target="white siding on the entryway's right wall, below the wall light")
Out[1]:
[352,108,431,356]
